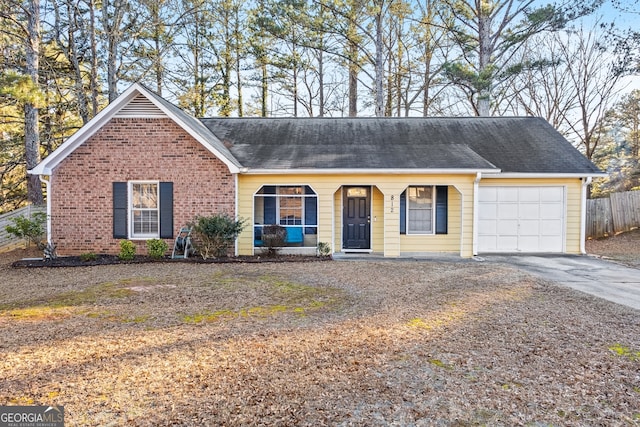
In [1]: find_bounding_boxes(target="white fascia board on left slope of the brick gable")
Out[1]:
[27,84,141,175]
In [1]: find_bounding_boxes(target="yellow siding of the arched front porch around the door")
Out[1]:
[238,174,475,257]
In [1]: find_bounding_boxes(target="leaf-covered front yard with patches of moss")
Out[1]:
[0,236,640,426]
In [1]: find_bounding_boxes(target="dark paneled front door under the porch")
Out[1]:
[342,187,371,249]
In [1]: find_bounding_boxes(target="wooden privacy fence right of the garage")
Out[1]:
[586,191,640,239]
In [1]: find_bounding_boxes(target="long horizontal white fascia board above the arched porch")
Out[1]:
[240,168,500,175]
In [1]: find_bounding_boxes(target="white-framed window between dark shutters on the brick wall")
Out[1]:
[129,181,160,239]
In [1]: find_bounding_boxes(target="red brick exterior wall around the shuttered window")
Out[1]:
[49,118,235,255]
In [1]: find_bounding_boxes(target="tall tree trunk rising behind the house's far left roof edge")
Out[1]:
[24,0,44,205]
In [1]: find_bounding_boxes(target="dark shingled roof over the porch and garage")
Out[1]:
[201,117,600,175]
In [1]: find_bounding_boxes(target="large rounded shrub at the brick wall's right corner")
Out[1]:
[189,214,245,259]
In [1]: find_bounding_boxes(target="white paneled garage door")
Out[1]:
[478,186,565,252]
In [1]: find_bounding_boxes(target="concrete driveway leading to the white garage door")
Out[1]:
[484,255,640,310]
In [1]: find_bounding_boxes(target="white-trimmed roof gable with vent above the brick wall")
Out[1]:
[28,83,240,175]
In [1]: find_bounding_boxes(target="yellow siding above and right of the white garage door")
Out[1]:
[480,178,582,254]
